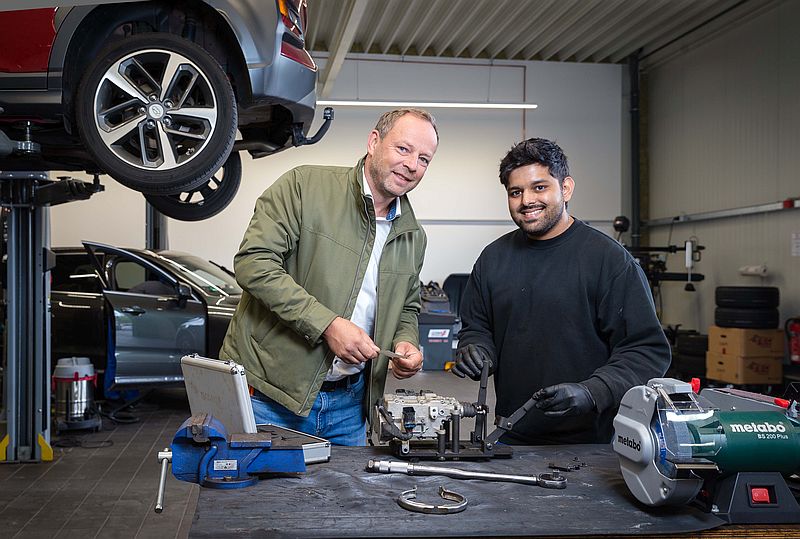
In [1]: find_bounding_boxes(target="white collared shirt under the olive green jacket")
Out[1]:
[325,172,400,381]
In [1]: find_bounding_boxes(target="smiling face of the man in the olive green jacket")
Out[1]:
[365,114,437,208]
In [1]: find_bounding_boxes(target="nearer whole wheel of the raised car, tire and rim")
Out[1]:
[75,32,237,195]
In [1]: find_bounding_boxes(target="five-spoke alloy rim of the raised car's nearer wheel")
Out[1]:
[94,49,219,171]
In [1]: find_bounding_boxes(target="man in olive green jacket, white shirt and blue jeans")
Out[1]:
[220,109,438,445]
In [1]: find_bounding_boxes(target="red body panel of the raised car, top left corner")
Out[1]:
[0,8,56,73]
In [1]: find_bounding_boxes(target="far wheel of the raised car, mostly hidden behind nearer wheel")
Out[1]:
[144,152,242,221]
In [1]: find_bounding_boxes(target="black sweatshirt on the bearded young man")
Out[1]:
[459,219,670,445]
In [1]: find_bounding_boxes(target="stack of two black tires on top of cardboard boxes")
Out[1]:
[714,286,780,329]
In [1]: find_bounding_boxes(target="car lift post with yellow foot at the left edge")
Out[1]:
[0,172,103,462]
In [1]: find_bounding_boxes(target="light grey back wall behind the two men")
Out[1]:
[52,56,623,282]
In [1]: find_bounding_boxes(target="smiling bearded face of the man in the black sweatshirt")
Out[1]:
[506,164,575,240]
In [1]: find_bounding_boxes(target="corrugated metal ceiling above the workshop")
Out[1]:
[306,0,780,95]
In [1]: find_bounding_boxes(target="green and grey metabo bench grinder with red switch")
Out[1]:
[613,378,800,523]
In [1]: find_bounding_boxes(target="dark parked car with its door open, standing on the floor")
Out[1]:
[50,242,242,389]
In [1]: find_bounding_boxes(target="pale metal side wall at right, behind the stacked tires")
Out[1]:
[647,1,800,332]
